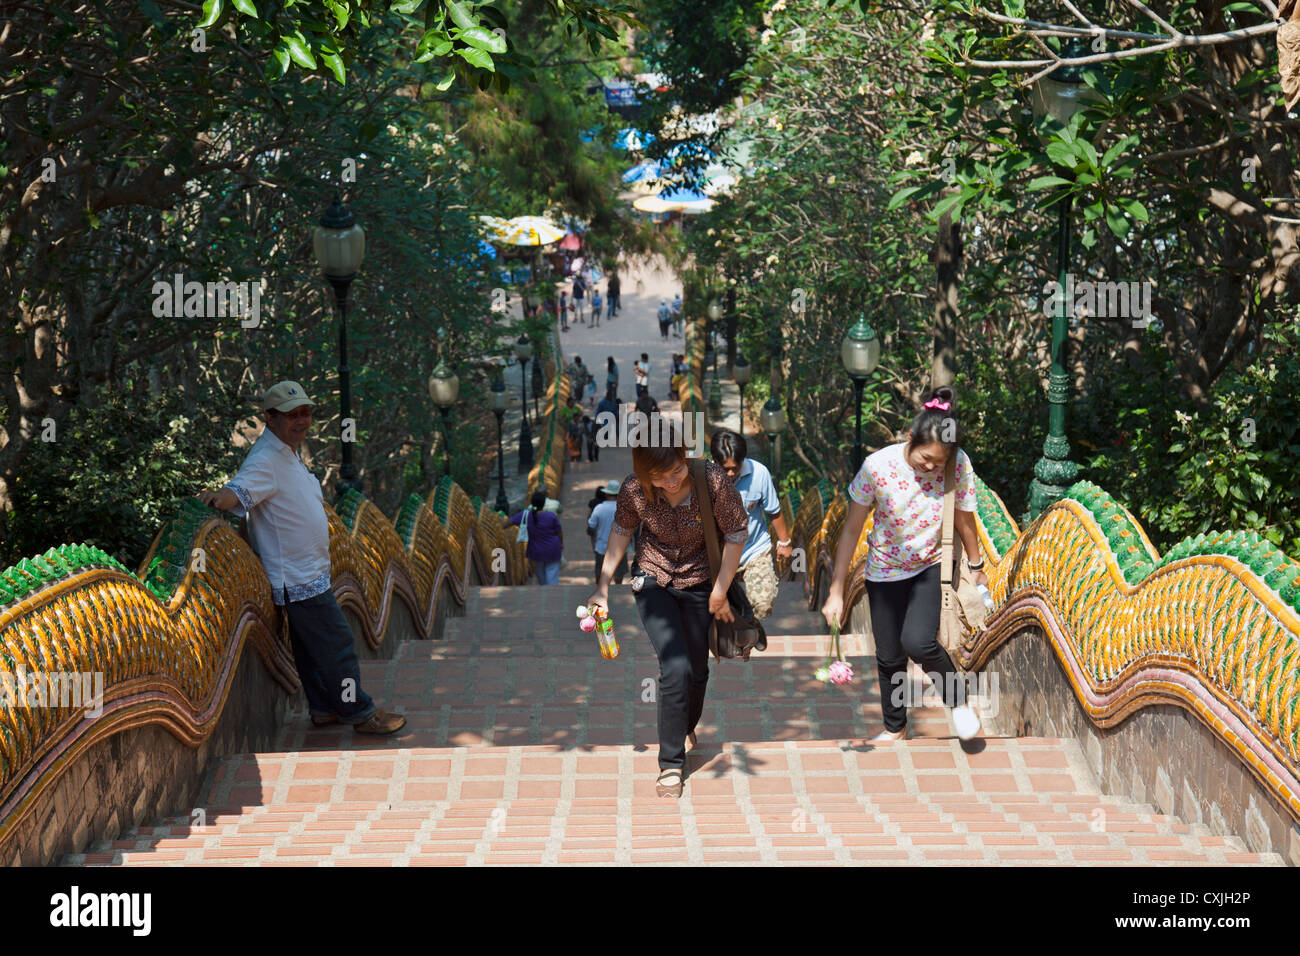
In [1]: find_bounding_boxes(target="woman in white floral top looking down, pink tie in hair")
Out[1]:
[822,388,988,740]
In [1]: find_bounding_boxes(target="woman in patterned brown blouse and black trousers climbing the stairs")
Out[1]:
[588,419,749,797]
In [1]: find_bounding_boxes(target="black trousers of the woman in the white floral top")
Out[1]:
[867,564,966,734]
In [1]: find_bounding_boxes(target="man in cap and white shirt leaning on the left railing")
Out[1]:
[199,381,406,734]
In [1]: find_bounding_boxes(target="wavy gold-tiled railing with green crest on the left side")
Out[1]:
[0,468,529,844]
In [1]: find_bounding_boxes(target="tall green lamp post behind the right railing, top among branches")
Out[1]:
[1028,40,1093,520]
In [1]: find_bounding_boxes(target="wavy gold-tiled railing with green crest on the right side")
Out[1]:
[794,481,1300,819]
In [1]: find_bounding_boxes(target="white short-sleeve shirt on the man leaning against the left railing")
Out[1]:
[226,428,330,605]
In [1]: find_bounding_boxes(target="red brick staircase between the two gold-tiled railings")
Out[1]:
[65,583,1282,866]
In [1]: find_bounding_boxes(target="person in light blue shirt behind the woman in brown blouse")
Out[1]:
[709,429,792,618]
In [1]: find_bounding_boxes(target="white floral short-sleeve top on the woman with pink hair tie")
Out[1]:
[849,442,976,581]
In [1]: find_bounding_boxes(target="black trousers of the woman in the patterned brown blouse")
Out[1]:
[636,576,712,770]
